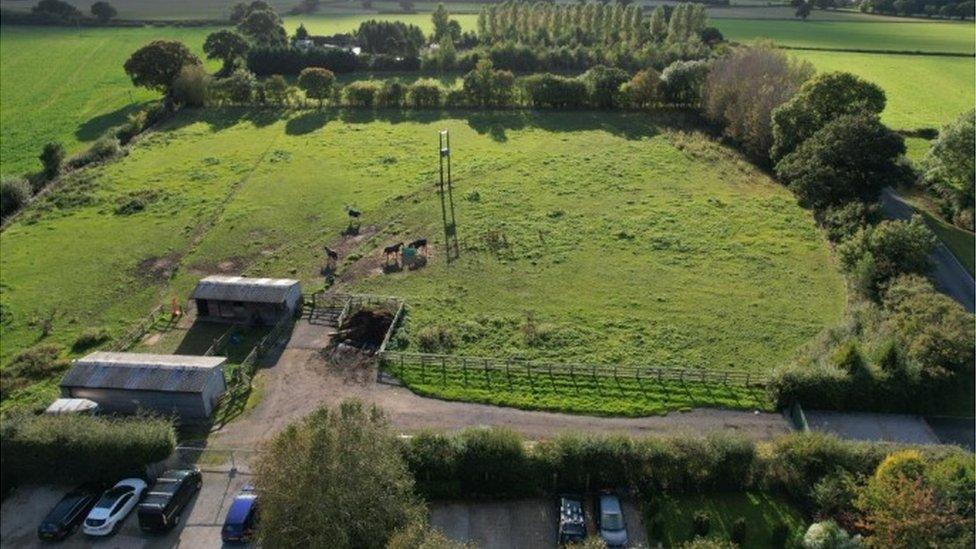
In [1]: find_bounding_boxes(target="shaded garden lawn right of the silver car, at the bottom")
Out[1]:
[646,492,805,549]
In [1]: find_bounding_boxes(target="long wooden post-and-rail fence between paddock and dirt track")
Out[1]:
[381,351,768,389]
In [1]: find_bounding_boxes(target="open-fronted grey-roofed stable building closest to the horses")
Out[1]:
[191,276,302,324]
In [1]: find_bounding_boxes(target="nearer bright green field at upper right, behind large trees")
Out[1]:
[790,51,976,129]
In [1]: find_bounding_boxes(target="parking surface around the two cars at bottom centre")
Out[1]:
[430,498,647,549]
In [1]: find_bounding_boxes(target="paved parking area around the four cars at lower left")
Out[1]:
[0,471,251,549]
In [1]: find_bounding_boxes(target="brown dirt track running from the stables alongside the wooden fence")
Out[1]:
[211,320,790,447]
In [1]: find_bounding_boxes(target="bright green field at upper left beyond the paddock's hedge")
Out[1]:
[0,25,213,174]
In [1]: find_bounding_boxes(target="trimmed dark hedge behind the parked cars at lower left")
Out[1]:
[0,415,176,491]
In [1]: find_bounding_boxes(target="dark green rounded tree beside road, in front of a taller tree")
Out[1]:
[776,115,911,209]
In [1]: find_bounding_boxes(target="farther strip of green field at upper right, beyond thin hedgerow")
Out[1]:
[714,19,976,53]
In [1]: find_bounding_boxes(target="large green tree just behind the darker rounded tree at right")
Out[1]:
[770,72,885,162]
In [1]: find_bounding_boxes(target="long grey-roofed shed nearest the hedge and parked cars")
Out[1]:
[61,352,227,420]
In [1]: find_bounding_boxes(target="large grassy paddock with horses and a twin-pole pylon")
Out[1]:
[0,110,844,413]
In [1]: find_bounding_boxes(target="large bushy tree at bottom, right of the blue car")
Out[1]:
[255,401,424,548]
